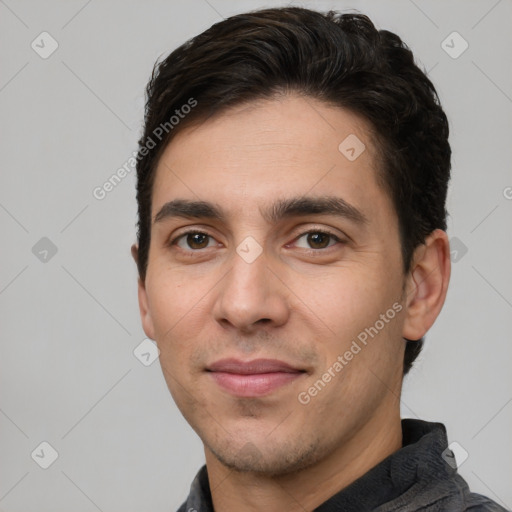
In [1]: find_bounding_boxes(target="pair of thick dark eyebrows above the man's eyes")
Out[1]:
[154,196,368,225]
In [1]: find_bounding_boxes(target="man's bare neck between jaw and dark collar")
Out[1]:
[205,408,402,512]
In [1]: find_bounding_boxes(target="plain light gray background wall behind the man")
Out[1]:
[0,0,512,512]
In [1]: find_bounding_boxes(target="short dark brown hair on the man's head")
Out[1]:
[137,7,451,374]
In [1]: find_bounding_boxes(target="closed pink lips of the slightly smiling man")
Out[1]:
[207,359,305,398]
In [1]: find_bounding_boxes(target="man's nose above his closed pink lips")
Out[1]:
[213,243,290,333]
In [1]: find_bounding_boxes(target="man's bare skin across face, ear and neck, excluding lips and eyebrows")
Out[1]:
[132,95,450,512]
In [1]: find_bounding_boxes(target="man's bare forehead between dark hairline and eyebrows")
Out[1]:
[152,96,392,226]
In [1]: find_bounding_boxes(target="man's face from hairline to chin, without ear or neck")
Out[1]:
[135,96,405,474]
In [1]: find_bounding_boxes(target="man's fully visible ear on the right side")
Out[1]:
[402,229,451,340]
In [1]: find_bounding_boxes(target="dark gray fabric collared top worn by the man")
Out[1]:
[178,419,507,512]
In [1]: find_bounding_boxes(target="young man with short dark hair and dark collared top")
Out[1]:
[132,8,504,512]
